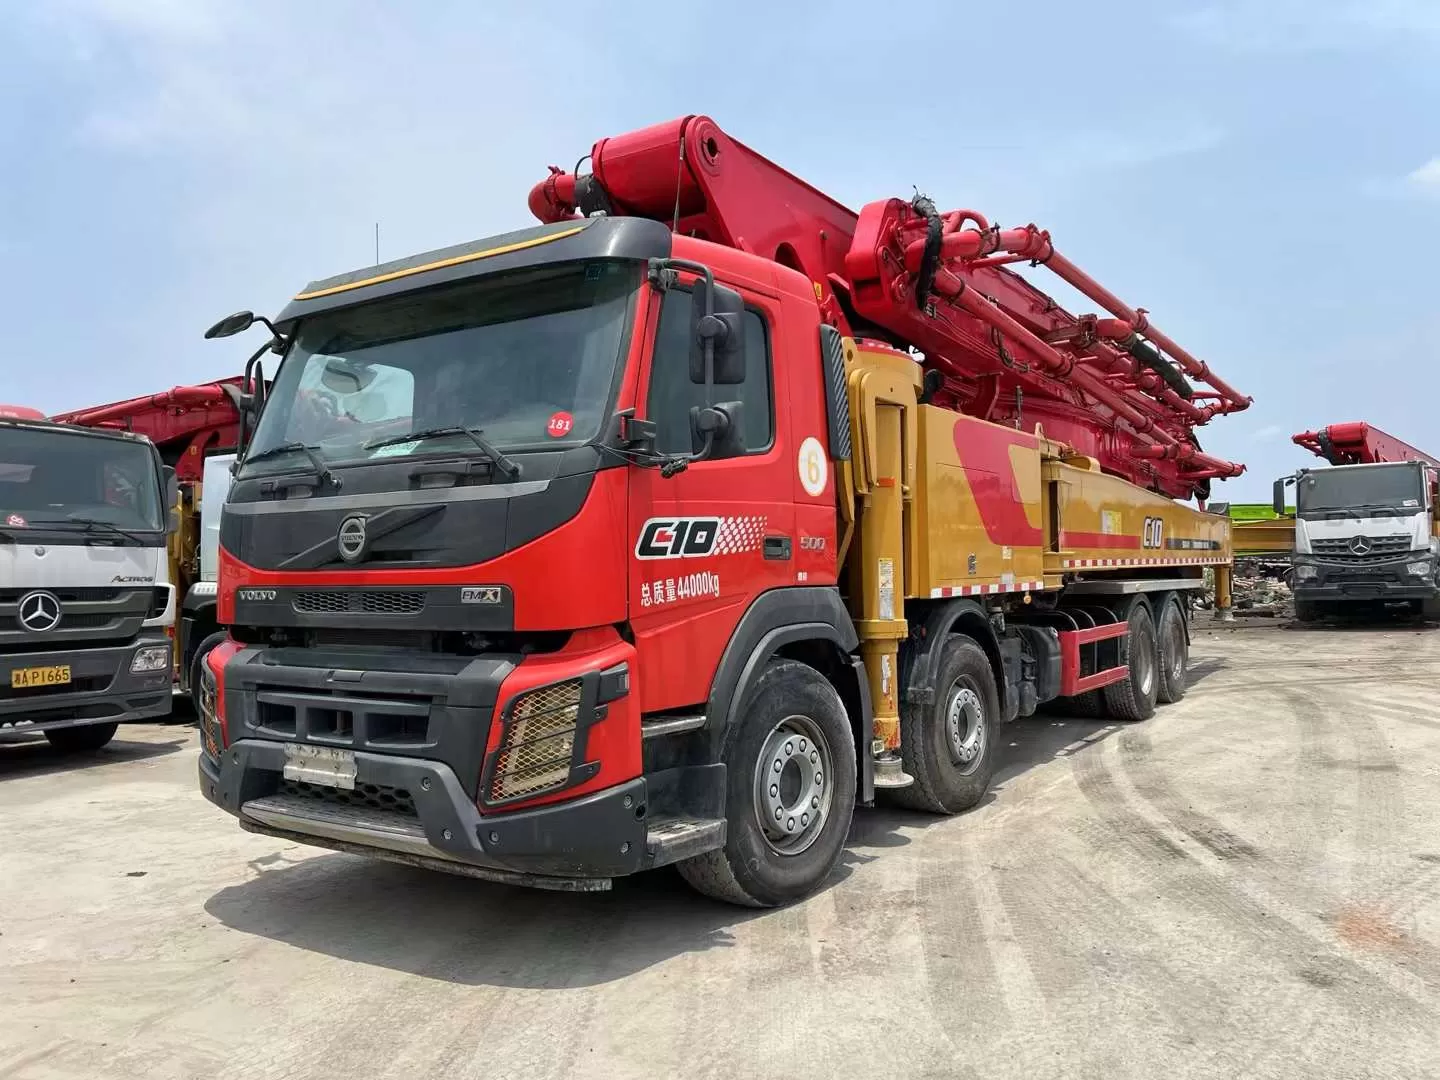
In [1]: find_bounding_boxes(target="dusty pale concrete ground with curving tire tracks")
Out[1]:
[0,626,1440,1080]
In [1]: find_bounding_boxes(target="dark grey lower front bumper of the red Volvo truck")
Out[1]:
[199,739,724,890]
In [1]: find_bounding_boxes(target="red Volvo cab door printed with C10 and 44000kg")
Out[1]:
[629,285,798,713]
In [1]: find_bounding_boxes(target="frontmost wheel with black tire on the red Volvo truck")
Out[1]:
[677,660,855,907]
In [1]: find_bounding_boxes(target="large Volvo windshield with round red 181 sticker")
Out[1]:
[246,262,639,471]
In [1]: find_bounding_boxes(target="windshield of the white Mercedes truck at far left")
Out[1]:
[0,425,164,531]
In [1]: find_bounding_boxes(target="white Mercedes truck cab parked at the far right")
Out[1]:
[1274,461,1440,622]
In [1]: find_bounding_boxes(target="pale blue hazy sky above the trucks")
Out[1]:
[0,0,1440,501]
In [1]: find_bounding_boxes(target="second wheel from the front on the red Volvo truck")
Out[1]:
[888,636,999,814]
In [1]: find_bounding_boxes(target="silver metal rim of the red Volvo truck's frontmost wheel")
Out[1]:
[755,716,835,855]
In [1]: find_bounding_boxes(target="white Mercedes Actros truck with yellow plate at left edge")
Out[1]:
[0,408,176,752]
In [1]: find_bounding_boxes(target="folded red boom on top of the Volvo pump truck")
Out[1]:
[530,117,1250,498]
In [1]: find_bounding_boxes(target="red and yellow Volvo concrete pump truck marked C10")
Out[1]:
[199,117,1248,904]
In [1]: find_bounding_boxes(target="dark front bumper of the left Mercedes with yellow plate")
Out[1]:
[0,632,171,732]
